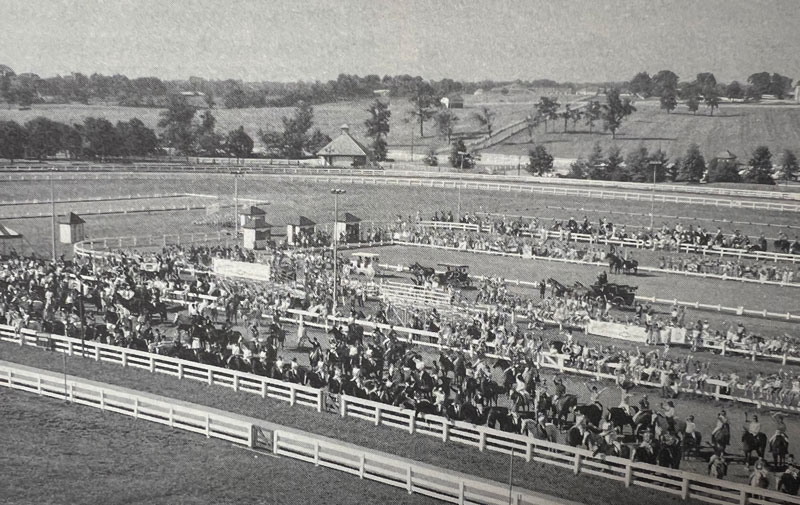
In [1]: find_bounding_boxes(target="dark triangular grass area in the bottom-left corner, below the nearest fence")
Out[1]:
[0,388,439,505]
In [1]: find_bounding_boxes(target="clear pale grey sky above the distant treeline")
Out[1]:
[0,0,800,82]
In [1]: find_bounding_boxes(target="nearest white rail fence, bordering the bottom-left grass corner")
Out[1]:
[0,363,563,505]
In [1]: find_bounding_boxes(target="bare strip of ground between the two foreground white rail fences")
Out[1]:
[0,343,712,505]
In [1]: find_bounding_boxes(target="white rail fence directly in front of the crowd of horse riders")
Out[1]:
[0,327,800,505]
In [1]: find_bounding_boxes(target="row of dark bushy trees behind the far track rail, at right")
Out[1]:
[564,144,800,184]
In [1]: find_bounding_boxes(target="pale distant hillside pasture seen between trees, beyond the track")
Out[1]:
[0,93,800,162]
